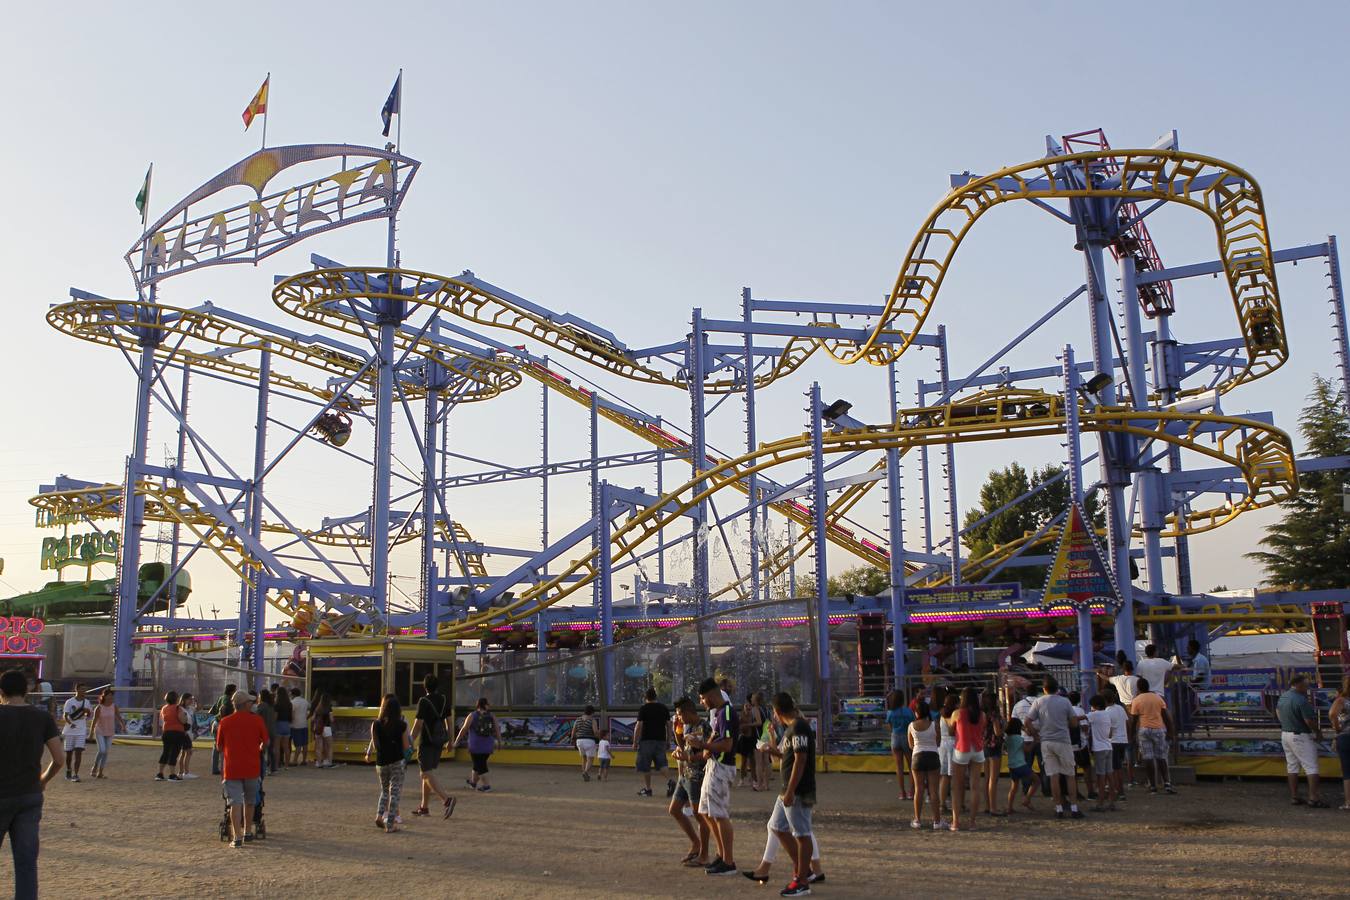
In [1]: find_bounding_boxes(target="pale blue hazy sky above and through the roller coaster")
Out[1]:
[0,3,1350,615]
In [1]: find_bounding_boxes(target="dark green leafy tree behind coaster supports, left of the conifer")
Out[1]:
[961,463,1106,590]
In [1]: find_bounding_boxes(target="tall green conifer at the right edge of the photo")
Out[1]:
[1246,375,1350,590]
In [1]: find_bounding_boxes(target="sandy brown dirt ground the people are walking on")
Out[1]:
[0,746,1350,900]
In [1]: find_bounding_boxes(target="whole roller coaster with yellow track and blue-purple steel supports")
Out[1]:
[23,126,1350,707]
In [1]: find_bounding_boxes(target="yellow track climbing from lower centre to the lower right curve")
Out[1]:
[440,391,1299,637]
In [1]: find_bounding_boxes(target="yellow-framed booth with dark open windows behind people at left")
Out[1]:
[305,637,458,761]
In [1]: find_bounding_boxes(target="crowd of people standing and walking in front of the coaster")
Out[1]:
[0,661,1350,897]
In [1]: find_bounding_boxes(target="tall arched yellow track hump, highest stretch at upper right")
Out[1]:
[826,150,1289,397]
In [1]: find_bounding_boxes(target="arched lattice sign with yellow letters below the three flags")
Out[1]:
[126,144,420,287]
